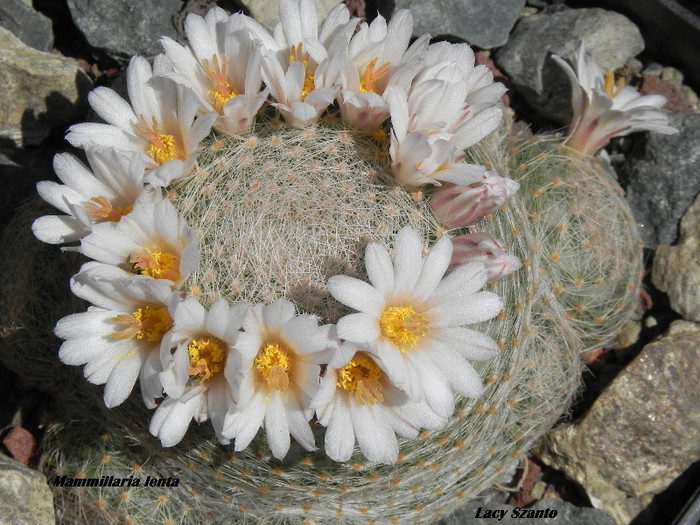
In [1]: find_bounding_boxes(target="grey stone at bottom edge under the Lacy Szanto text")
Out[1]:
[439,498,615,525]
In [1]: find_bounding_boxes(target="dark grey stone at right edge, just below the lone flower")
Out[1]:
[620,114,700,248]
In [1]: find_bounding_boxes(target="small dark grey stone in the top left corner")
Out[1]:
[0,0,53,51]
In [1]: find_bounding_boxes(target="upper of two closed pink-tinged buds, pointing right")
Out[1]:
[430,171,520,228]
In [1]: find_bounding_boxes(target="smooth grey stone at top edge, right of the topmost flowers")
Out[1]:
[378,0,525,49]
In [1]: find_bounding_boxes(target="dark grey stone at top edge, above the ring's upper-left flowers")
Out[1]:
[68,0,182,61]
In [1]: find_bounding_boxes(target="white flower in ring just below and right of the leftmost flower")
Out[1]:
[78,192,199,286]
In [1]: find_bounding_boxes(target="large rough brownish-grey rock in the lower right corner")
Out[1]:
[540,321,700,525]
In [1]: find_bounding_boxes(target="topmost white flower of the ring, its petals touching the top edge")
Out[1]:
[262,0,356,126]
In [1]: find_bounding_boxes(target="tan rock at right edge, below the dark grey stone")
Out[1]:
[651,195,700,323]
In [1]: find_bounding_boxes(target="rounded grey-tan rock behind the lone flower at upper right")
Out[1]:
[496,8,644,124]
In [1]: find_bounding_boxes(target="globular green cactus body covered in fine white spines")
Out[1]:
[2,113,640,524]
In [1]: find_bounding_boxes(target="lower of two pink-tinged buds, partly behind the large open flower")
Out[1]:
[447,232,523,283]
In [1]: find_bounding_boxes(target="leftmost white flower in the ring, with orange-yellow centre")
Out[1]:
[32,146,145,244]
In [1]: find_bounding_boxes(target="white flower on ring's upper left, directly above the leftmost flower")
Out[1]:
[66,55,217,185]
